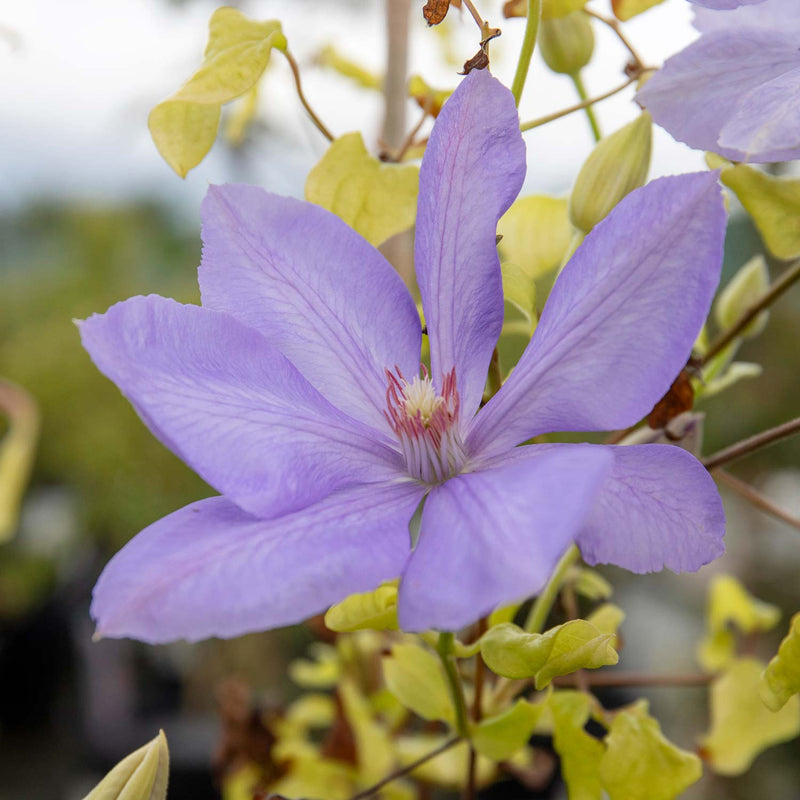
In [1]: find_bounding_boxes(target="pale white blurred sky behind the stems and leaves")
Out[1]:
[0,0,702,220]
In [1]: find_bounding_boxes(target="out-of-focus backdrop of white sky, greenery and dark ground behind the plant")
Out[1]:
[0,0,800,800]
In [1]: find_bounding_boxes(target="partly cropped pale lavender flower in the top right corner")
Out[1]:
[636,0,800,163]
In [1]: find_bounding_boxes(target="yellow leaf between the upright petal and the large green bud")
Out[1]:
[497,195,572,280]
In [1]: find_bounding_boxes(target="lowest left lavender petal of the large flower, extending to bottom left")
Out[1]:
[91,482,423,644]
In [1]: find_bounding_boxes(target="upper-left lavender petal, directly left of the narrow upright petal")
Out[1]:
[199,185,422,430]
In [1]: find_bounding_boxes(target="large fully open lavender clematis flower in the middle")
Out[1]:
[81,71,725,642]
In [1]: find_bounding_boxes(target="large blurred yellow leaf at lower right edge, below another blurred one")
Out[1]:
[701,658,800,775]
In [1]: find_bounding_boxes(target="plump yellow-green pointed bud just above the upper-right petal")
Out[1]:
[569,111,653,233]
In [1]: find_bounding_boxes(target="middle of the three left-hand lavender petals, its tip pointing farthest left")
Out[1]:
[80,296,400,517]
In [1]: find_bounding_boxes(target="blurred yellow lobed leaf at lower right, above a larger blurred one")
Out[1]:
[698,575,781,672]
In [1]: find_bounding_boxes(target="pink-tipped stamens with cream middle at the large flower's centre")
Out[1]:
[385,366,467,484]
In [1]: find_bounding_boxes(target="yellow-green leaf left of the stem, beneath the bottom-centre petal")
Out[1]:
[383,644,454,722]
